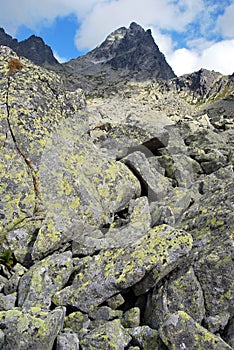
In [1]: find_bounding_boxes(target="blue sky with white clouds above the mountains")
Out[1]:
[0,0,234,76]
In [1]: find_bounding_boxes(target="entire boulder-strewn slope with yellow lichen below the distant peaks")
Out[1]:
[0,21,234,350]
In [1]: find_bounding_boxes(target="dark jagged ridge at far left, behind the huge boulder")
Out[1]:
[0,28,59,66]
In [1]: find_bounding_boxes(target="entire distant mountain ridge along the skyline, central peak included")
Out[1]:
[0,22,234,103]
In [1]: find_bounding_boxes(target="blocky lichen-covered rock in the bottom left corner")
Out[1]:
[0,308,65,350]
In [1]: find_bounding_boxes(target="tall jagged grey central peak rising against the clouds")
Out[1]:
[65,22,176,80]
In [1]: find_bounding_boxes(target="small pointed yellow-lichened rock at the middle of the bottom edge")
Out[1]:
[80,320,131,350]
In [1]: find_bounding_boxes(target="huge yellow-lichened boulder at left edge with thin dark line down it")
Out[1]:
[0,47,85,254]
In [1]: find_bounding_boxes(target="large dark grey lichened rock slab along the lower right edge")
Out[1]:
[180,178,234,330]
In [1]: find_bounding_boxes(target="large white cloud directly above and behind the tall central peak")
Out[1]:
[75,0,204,50]
